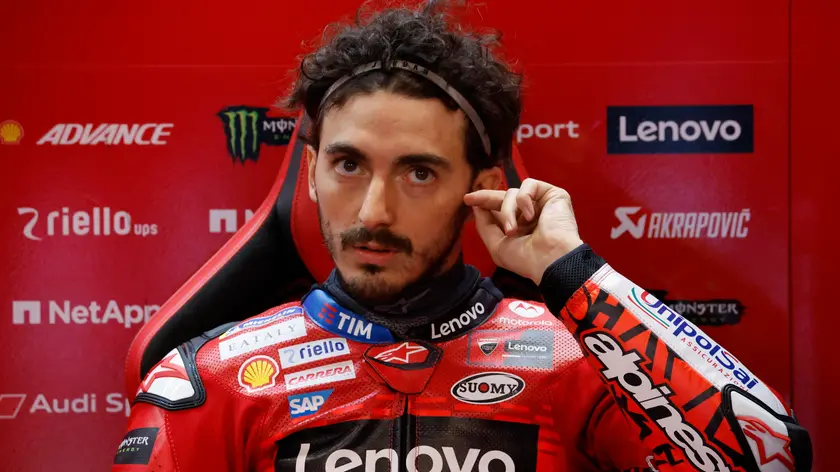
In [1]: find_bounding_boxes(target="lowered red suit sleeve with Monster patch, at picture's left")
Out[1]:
[112,343,256,472]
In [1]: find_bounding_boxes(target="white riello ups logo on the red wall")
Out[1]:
[18,207,158,241]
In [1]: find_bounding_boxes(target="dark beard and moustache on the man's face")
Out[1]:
[318,199,470,306]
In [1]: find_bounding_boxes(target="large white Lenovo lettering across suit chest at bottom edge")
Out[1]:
[295,443,516,472]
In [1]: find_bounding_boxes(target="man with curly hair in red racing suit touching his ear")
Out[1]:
[114,3,811,472]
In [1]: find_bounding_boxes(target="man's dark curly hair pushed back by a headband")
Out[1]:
[283,0,522,171]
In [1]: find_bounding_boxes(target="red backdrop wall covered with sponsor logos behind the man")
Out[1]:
[0,0,840,471]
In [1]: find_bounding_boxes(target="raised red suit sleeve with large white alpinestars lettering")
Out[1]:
[540,244,811,472]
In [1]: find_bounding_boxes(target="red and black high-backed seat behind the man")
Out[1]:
[125,117,536,399]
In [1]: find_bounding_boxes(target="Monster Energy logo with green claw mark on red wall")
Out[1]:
[218,106,296,164]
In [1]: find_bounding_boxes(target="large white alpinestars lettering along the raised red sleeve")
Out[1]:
[583,333,730,472]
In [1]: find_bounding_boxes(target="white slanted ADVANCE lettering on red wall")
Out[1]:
[37,123,175,146]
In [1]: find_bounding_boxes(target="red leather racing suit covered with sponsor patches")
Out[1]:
[113,245,811,472]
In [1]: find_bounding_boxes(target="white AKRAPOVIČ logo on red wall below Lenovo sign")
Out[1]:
[610,207,751,239]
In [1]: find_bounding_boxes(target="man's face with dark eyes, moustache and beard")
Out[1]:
[308,91,501,302]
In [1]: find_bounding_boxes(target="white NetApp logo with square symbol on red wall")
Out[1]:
[12,300,160,328]
